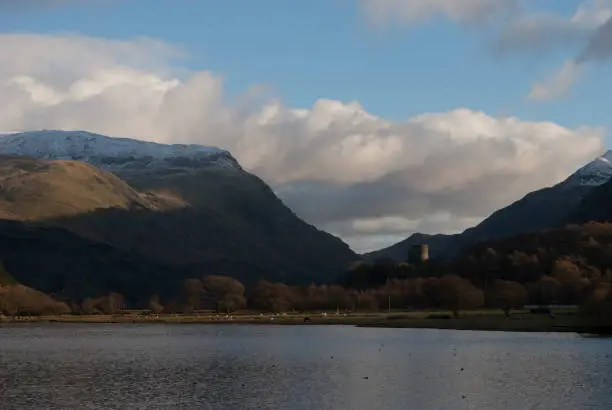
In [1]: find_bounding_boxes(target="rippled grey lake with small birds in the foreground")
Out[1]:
[0,324,612,410]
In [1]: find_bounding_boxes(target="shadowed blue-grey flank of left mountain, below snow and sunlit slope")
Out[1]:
[49,165,357,284]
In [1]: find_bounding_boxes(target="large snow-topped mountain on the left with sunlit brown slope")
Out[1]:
[0,131,359,297]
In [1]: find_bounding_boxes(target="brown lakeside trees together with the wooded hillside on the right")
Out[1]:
[0,223,612,318]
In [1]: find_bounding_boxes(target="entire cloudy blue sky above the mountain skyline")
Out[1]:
[0,0,612,252]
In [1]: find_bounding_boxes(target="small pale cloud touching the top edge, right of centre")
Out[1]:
[358,0,518,24]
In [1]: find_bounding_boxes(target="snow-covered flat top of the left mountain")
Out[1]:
[0,130,241,171]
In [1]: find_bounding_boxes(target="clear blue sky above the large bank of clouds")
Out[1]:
[0,0,612,135]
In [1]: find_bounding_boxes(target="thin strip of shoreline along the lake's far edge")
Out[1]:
[0,313,612,335]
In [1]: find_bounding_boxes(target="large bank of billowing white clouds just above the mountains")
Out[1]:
[0,35,603,250]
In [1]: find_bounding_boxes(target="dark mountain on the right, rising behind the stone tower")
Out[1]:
[365,151,612,260]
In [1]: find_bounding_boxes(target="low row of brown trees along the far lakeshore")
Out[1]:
[0,270,612,317]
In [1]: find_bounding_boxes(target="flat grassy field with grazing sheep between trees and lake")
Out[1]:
[0,309,596,332]
